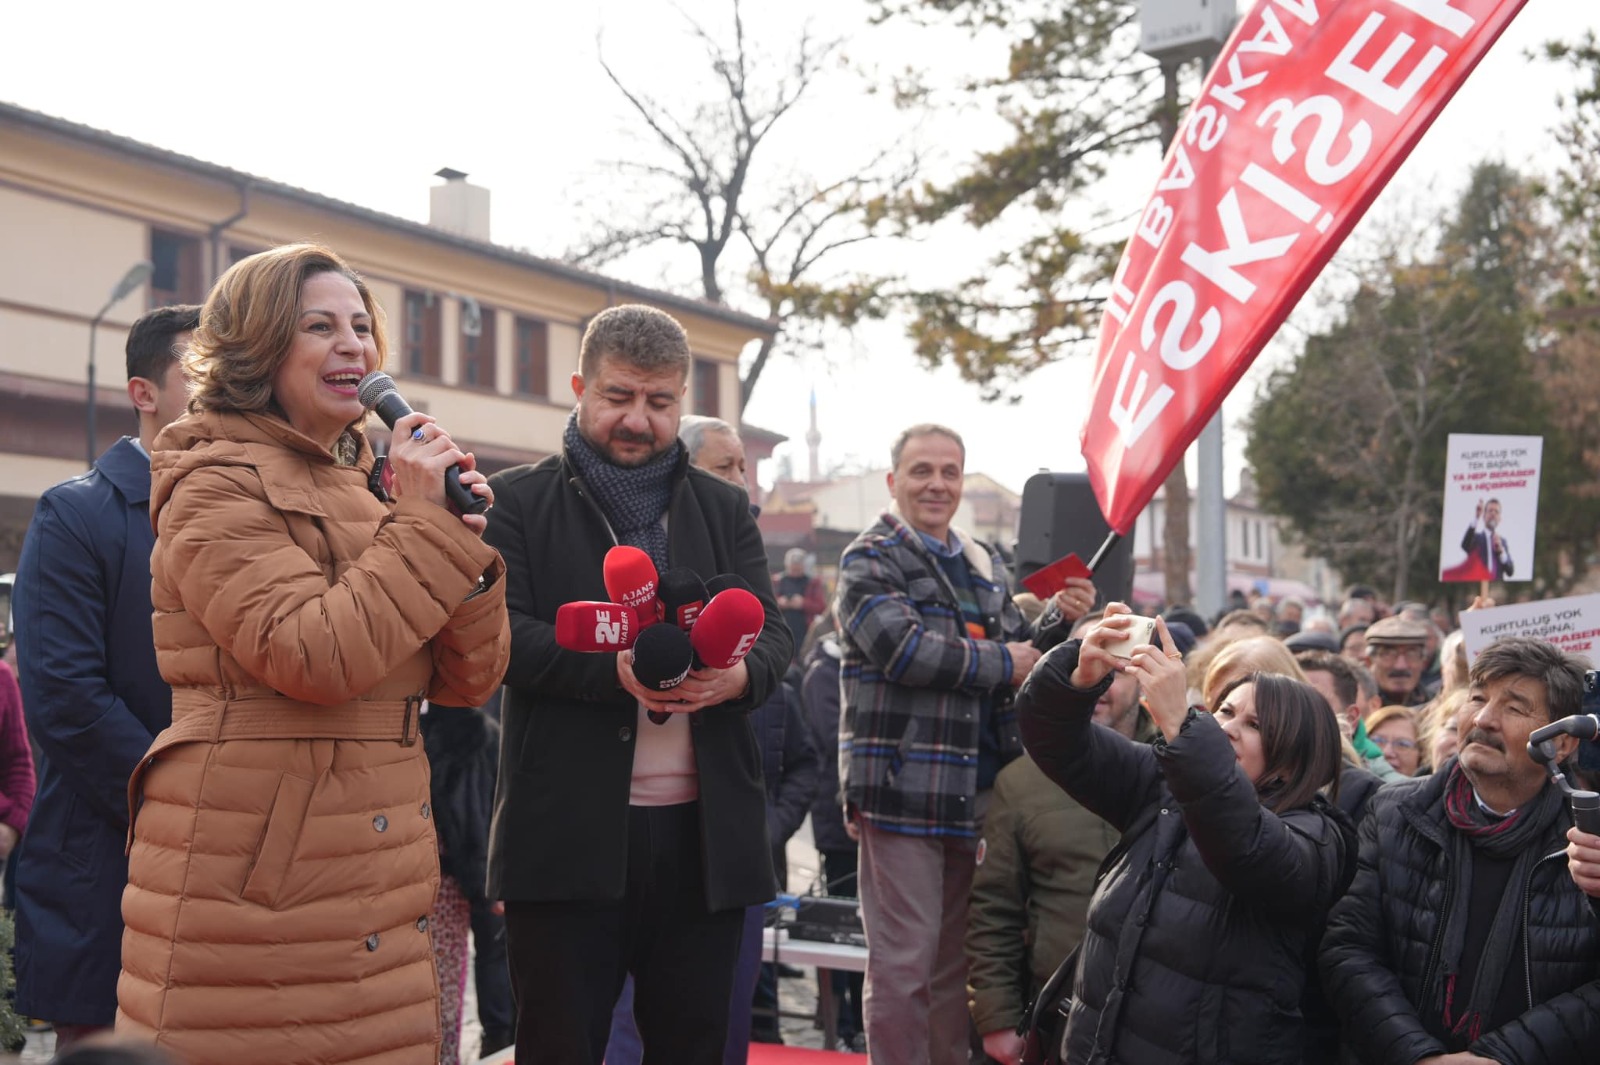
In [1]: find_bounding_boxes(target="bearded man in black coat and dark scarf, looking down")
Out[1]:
[485,305,790,1065]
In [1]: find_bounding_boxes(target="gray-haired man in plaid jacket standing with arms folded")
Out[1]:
[838,424,1093,1065]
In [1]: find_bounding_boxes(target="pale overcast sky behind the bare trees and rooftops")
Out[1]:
[0,0,1600,491]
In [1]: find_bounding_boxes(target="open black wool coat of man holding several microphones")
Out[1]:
[483,444,792,910]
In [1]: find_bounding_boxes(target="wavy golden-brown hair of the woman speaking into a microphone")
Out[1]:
[184,243,389,413]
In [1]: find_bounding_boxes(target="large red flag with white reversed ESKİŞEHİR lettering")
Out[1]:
[1083,0,1526,534]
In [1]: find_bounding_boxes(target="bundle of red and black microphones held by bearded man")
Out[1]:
[555,544,766,724]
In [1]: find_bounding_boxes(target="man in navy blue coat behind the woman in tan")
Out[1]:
[13,305,200,1052]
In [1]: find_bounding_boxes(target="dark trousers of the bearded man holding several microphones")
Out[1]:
[506,803,744,1065]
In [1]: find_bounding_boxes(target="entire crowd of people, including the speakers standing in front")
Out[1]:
[0,245,1600,1065]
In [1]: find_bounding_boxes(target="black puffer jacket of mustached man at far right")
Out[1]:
[1322,763,1600,1065]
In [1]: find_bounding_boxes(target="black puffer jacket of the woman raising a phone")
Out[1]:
[1016,641,1355,1065]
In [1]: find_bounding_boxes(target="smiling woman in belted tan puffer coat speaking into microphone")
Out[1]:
[117,245,510,1065]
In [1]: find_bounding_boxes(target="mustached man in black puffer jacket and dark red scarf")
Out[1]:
[1322,636,1600,1065]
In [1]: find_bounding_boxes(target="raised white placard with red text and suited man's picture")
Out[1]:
[1438,433,1544,580]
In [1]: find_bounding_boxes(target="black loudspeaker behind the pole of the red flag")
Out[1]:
[1016,472,1133,604]
